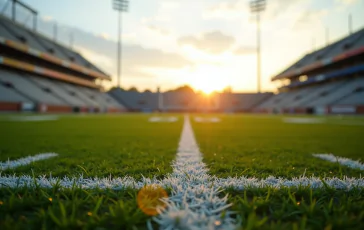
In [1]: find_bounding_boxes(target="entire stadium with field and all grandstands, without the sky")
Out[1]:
[0,0,364,230]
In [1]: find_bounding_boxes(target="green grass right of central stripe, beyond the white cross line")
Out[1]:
[193,115,364,178]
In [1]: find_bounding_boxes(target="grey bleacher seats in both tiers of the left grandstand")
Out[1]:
[0,15,125,111]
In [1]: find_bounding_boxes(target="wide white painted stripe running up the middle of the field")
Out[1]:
[148,115,237,229]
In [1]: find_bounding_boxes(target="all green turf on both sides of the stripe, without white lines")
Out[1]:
[0,114,364,230]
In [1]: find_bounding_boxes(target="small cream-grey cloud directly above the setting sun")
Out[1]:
[178,31,235,54]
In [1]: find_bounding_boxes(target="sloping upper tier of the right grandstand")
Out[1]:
[272,29,364,81]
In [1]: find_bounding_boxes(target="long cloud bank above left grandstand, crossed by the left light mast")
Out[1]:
[34,17,193,82]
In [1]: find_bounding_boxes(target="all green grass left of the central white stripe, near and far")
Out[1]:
[0,114,183,229]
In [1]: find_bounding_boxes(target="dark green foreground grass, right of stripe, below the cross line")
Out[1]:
[225,188,364,230]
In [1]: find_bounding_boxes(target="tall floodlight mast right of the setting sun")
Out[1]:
[250,0,267,93]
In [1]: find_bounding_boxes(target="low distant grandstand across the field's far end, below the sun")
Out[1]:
[109,88,273,112]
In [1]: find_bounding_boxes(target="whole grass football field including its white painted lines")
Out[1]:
[0,114,364,229]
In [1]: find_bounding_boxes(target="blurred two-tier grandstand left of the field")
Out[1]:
[0,12,125,112]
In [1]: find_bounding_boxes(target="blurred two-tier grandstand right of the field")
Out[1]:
[254,29,364,114]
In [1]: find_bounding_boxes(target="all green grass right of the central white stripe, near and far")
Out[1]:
[193,115,364,230]
